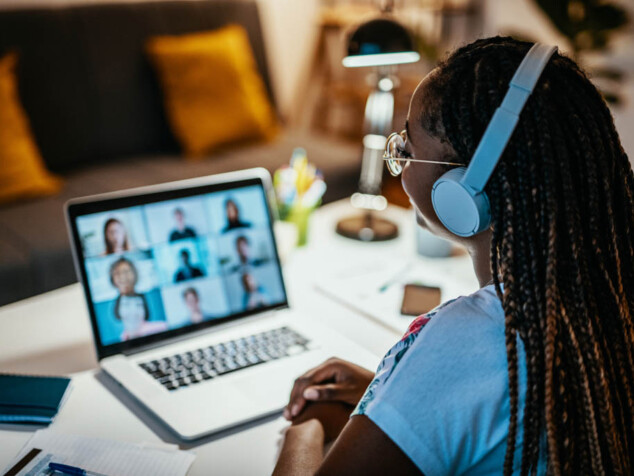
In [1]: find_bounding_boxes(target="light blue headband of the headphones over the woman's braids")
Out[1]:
[461,43,557,192]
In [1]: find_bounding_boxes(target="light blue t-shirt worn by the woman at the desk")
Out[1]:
[353,285,546,476]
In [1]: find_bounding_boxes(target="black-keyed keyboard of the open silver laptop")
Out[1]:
[139,327,309,391]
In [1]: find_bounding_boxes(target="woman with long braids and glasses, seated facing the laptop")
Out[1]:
[276,37,634,476]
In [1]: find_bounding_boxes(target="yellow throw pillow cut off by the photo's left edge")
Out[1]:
[0,53,62,204]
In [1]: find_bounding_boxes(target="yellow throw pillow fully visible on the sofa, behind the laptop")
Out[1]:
[147,25,278,157]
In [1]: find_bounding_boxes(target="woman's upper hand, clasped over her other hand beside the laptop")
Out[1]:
[284,357,374,420]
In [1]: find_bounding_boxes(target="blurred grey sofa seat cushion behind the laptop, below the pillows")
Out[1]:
[0,131,360,305]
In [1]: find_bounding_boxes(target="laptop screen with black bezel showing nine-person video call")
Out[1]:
[68,173,287,358]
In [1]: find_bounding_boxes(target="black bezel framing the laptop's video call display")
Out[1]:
[65,169,288,360]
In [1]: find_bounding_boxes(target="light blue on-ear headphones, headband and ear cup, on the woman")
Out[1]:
[431,43,557,236]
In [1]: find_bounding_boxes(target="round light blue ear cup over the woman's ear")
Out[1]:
[431,167,491,237]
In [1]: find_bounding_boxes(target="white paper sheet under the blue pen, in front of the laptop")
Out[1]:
[3,430,195,476]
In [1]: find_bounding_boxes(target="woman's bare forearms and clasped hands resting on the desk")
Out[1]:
[273,359,421,476]
